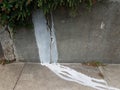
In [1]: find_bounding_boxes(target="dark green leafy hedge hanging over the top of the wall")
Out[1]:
[0,0,97,27]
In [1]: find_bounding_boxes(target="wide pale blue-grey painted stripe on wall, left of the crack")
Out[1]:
[33,10,51,64]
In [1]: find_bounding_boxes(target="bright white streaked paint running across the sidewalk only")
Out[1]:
[45,64,120,90]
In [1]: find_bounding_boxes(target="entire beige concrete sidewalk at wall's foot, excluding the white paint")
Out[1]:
[0,63,120,90]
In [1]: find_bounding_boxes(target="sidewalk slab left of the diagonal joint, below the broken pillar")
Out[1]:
[0,63,24,90]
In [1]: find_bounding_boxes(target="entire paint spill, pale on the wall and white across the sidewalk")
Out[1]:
[33,10,120,90]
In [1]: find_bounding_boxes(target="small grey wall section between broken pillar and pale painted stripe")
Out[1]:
[15,28,40,62]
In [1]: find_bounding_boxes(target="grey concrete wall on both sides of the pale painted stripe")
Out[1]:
[15,0,120,63]
